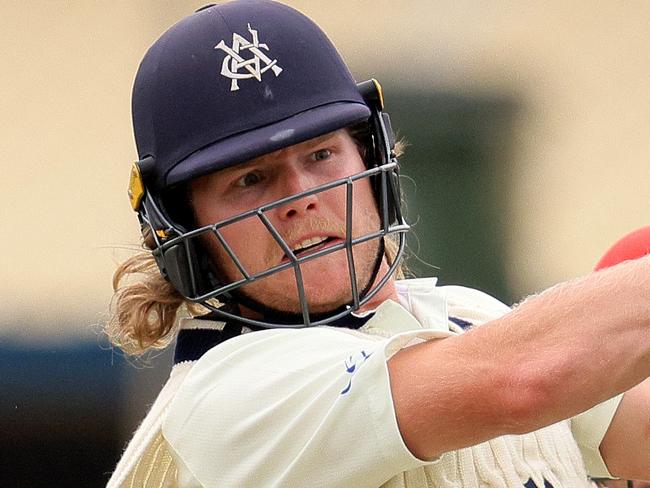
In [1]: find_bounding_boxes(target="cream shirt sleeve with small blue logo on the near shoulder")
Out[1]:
[163,327,446,487]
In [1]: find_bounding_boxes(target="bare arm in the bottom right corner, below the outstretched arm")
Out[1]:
[600,380,650,479]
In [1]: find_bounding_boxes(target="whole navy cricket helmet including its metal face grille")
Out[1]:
[129,0,408,327]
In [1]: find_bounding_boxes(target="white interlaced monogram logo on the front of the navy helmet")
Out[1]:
[214,24,282,91]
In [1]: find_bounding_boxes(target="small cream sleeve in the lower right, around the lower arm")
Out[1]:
[571,394,623,478]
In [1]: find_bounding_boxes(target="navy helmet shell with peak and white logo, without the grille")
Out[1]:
[132,0,370,190]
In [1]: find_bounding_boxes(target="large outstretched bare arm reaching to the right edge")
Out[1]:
[388,257,650,459]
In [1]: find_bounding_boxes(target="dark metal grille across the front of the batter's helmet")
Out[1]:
[148,162,409,327]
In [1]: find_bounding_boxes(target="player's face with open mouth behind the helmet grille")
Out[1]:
[190,129,385,313]
